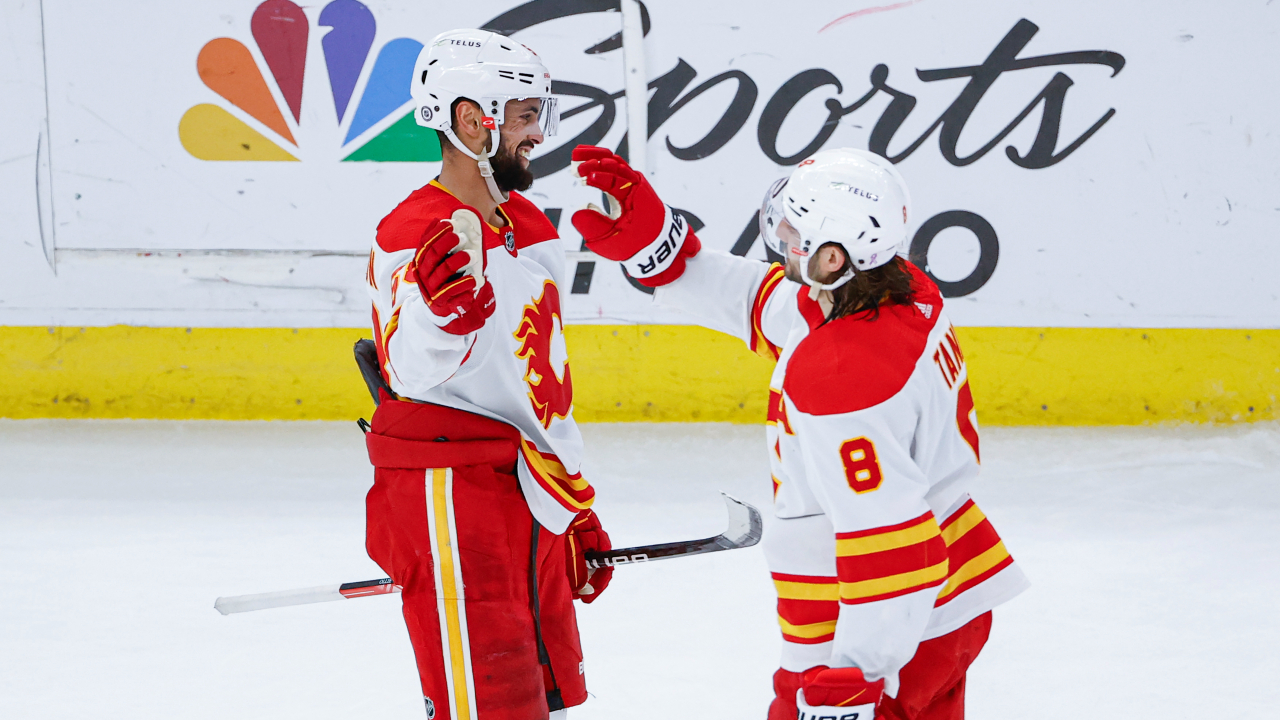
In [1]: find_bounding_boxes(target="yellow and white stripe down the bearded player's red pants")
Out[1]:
[431,468,471,720]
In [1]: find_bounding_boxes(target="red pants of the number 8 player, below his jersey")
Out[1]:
[769,612,991,720]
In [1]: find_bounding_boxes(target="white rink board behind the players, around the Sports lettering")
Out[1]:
[0,0,1280,328]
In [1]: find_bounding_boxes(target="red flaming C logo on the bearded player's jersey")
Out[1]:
[515,281,573,428]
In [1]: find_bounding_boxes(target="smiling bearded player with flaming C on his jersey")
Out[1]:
[366,29,612,720]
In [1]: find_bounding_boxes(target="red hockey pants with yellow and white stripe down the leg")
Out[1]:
[365,398,586,720]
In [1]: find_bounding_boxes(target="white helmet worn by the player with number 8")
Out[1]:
[782,147,911,290]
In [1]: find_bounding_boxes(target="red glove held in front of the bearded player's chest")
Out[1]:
[412,213,497,334]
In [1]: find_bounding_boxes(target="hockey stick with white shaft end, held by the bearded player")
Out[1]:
[214,493,764,615]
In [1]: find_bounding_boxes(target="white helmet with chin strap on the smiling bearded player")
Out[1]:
[410,29,559,202]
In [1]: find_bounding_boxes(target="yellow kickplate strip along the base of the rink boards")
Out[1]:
[0,326,1280,427]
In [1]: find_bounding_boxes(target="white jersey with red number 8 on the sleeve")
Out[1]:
[655,250,1028,694]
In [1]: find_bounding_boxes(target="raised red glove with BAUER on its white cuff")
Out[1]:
[572,145,703,287]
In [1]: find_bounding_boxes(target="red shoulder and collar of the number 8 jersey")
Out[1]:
[783,263,942,415]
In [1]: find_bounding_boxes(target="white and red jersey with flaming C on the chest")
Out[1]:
[366,181,595,533]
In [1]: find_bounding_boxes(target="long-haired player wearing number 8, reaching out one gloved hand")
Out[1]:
[573,142,1027,720]
